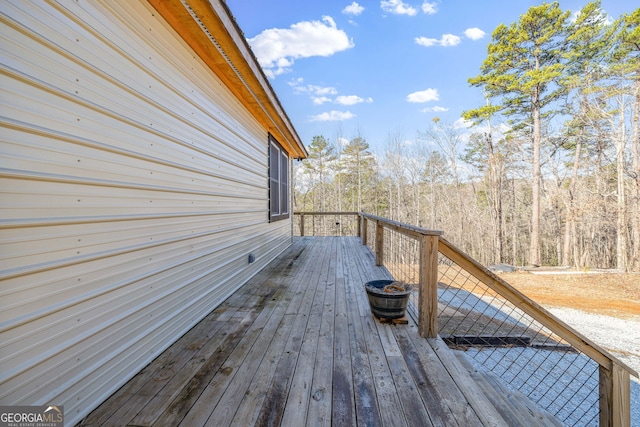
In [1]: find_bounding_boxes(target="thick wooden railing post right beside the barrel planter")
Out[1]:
[418,235,439,338]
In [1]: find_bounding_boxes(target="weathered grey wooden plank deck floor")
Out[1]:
[81,237,554,427]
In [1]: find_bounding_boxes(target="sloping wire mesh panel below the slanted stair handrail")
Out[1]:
[438,254,599,426]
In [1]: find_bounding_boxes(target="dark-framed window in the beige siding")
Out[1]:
[269,135,289,221]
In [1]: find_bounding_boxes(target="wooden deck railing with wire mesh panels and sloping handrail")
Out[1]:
[294,212,638,426]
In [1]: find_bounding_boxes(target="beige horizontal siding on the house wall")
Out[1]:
[0,0,291,425]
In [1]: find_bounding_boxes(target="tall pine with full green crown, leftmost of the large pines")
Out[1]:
[467,2,569,265]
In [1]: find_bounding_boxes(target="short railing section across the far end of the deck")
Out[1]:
[293,214,358,237]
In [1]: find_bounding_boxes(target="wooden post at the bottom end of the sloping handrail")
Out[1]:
[599,362,631,427]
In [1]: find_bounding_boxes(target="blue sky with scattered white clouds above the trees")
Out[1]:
[227,0,637,152]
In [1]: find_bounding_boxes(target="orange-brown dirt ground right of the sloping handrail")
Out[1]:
[499,272,640,319]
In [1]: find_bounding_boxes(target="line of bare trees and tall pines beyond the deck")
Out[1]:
[294,1,640,271]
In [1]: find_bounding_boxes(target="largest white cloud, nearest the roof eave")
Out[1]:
[248,16,354,78]
